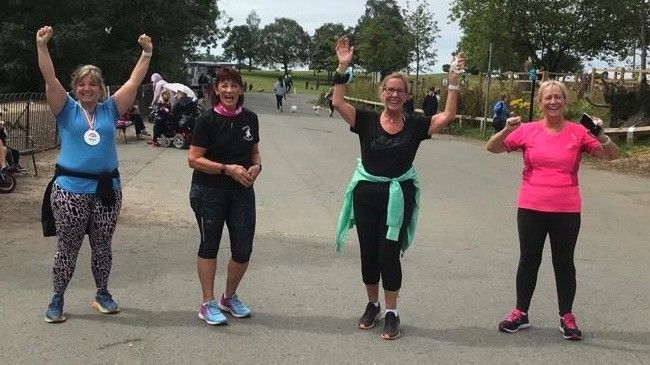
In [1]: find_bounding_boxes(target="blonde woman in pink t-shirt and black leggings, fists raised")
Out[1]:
[487,80,619,340]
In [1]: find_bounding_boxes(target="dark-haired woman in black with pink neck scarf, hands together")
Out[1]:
[188,68,262,325]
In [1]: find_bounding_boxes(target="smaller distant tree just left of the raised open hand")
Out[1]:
[309,23,352,79]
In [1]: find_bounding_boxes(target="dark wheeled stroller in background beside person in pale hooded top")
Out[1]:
[158,96,199,149]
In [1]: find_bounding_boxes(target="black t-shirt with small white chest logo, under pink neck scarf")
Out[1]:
[192,108,260,190]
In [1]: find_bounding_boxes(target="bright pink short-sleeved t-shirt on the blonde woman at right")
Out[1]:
[504,121,600,213]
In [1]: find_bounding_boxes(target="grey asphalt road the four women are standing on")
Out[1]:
[0,94,650,364]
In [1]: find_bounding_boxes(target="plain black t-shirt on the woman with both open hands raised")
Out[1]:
[350,109,431,178]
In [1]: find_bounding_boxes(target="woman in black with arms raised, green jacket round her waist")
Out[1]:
[332,37,464,340]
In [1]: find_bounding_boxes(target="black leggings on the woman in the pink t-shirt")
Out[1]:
[517,208,580,316]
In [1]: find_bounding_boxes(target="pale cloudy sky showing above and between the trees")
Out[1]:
[218,0,460,68]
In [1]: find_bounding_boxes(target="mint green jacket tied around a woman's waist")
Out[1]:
[336,159,420,252]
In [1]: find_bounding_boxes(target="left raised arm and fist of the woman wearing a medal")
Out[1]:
[36,26,68,115]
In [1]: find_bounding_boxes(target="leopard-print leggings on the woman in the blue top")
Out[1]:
[51,183,122,295]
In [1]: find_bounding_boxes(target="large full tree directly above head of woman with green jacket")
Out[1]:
[354,0,413,78]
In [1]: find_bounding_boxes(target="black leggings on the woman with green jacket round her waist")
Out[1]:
[353,180,415,291]
